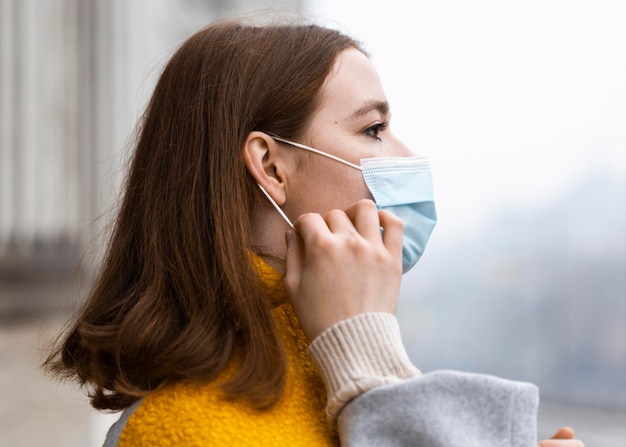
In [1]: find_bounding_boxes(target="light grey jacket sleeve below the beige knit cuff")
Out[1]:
[338,371,539,447]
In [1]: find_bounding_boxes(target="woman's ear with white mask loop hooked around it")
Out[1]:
[243,130,287,206]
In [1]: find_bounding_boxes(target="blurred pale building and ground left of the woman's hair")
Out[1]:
[0,0,299,447]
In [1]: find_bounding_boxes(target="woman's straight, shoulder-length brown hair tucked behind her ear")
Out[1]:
[44,22,359,410]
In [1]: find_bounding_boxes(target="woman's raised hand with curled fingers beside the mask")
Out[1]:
[285,200,402,340]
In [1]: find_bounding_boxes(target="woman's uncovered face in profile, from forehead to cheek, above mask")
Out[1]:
[285,48,414,221]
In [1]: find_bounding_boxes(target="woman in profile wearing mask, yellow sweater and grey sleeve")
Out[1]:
[47,17,580,446]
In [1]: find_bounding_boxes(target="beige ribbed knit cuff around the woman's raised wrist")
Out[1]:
[309,313,421,421]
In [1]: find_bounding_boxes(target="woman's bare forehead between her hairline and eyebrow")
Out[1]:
[317,48,386,121]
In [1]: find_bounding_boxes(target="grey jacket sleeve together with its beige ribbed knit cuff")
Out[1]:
[309,313,539,447]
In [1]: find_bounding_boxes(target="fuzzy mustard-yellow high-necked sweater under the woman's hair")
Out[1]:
[118,257,339,447]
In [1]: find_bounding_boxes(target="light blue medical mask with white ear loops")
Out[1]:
[259,137,437,273]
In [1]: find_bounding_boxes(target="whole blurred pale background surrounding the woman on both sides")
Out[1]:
[0,0,626,447]
